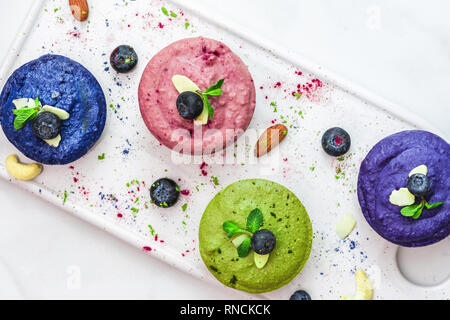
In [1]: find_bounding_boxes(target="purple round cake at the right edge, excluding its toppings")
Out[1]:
[358,130,450,247]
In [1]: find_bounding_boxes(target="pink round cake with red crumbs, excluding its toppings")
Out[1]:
[139,37,256,154]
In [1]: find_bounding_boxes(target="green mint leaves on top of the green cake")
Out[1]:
[222,208,264,258]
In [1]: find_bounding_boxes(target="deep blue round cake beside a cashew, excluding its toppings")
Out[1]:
[0,54,106,165]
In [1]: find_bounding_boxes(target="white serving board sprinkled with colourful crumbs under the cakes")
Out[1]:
[0,0,449,299]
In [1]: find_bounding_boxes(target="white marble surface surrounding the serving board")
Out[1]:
[0,0,450,299]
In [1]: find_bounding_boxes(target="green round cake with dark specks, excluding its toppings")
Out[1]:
[199,179,312,293]
